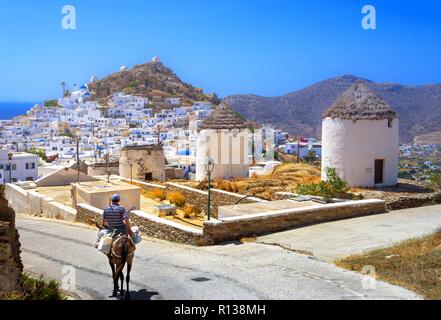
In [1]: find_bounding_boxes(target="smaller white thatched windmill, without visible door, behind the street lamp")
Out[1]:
[196,103,249,181]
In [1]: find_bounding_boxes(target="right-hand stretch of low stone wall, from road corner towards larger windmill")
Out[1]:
[204,200,387,244]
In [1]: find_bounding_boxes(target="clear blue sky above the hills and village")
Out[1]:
[0,0,441,101]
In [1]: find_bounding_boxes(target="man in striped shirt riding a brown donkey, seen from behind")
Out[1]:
[100,194,136,299]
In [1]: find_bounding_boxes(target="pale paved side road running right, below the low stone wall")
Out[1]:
[258,206,441,261]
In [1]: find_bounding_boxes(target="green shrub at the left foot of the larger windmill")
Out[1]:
[296,168,352,203]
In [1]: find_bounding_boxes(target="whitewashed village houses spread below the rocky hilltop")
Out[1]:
[0,57,321,186]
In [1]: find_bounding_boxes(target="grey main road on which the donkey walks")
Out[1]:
[17,217,419,300]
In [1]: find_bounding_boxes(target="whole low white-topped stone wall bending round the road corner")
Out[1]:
[76,196,386,246]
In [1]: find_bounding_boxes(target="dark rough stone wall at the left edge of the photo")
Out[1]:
[0,190,23,300]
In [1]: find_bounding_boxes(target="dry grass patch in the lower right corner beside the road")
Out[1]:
[336,232,441,300]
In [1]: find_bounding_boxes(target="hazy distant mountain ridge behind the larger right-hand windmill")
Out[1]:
[225,75,441,142]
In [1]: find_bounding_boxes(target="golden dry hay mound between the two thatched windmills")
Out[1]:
[235,163,321,200]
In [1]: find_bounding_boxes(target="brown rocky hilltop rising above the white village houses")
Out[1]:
[89,62,220,105]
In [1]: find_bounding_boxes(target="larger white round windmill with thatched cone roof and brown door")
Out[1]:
[322,81,399,187]
